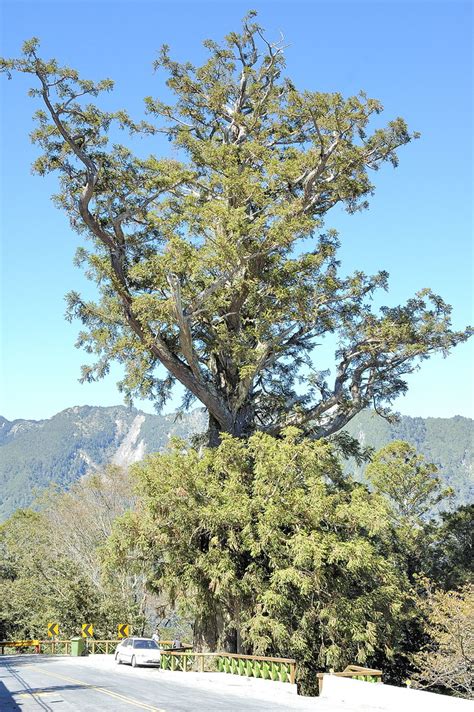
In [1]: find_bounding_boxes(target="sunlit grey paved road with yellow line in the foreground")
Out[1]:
[0,655,326,712]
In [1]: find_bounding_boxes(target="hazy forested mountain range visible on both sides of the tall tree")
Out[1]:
[0,406,474,520]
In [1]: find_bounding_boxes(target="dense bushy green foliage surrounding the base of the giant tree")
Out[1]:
[108,429,410,689]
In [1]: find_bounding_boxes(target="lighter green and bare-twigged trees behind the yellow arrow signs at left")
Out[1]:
[0,468,150,639]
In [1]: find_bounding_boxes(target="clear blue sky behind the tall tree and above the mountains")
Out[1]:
[0,0,473,419]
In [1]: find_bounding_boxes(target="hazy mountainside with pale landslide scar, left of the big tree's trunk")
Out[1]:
[0,406,205,519]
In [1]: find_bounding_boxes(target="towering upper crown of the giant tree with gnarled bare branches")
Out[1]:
[2,13,467,445]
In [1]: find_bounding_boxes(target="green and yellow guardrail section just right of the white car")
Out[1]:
[161,651,296,684]
